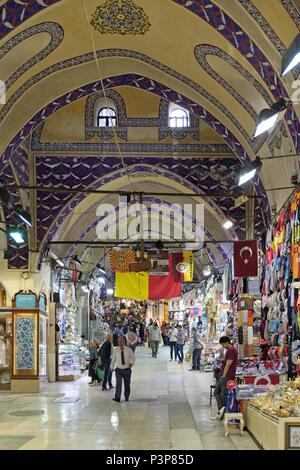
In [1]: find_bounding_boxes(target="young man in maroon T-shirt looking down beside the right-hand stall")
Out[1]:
[214,336,238,420]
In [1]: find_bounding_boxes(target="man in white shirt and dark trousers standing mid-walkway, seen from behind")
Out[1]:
[111,337,135,403]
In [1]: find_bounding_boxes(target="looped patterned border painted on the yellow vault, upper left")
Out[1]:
[0,22,64,91]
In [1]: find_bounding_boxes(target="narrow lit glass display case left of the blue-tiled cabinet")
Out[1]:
[0,312,12,390]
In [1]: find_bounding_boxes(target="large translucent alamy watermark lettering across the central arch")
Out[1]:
[96,196,204,244]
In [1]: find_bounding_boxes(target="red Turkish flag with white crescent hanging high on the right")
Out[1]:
[233,240,258,277]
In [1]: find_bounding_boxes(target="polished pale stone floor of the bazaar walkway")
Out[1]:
[0,347,257,450]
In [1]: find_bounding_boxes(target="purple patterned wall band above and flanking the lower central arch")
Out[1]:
[36,156,248,246]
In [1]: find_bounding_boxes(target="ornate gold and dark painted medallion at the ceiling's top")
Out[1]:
[91,0,151,35]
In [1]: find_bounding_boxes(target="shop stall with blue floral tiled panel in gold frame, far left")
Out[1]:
[0,291,48,393]
